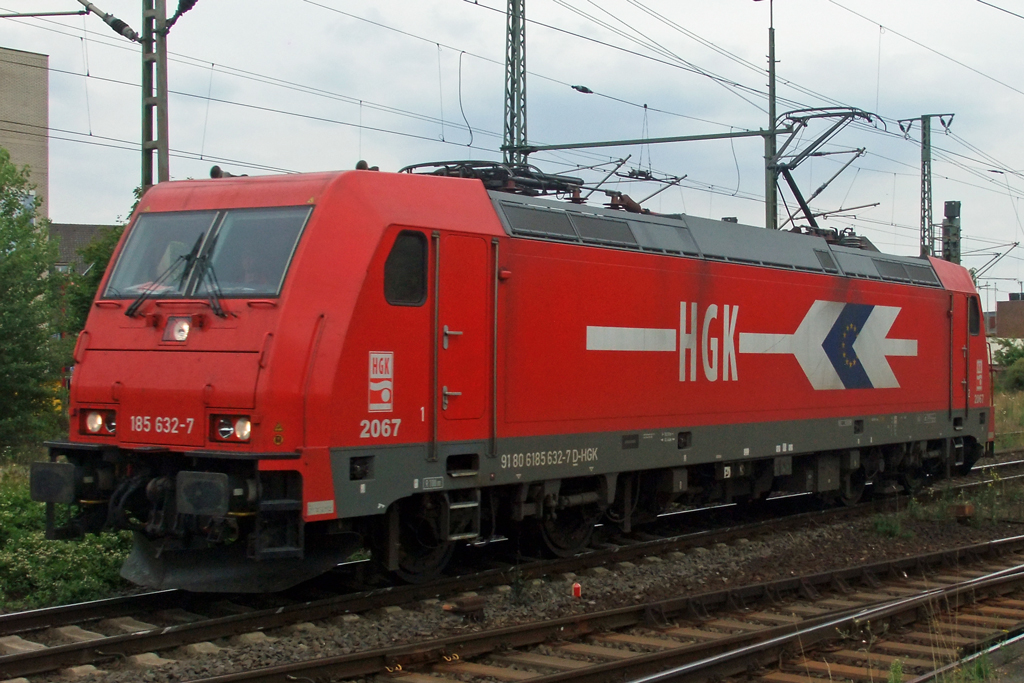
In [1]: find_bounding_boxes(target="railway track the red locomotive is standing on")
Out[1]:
[0,456,1020,683]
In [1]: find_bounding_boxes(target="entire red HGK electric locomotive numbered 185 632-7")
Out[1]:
[31,163,992,591]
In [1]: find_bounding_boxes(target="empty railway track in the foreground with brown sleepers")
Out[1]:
[148,538,1024,683]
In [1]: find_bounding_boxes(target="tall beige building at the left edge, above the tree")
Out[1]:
[0,47,50,217]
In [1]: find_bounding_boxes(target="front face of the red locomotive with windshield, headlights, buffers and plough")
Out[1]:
[31,172,365,591]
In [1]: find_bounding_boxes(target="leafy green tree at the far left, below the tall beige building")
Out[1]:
[0,147,66,453]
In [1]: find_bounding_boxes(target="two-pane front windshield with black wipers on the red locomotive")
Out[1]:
[103,207,311,299]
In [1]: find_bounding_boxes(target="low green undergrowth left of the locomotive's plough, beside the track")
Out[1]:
[0,464,131,611]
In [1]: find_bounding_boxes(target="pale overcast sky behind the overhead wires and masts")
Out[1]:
[0,0,1024,307]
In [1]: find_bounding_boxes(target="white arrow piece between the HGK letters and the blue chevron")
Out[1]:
[739,301,846,389]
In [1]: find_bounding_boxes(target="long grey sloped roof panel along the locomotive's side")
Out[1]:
[490,191,941,287]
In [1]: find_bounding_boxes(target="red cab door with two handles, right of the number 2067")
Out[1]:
[435,233,493,443]
